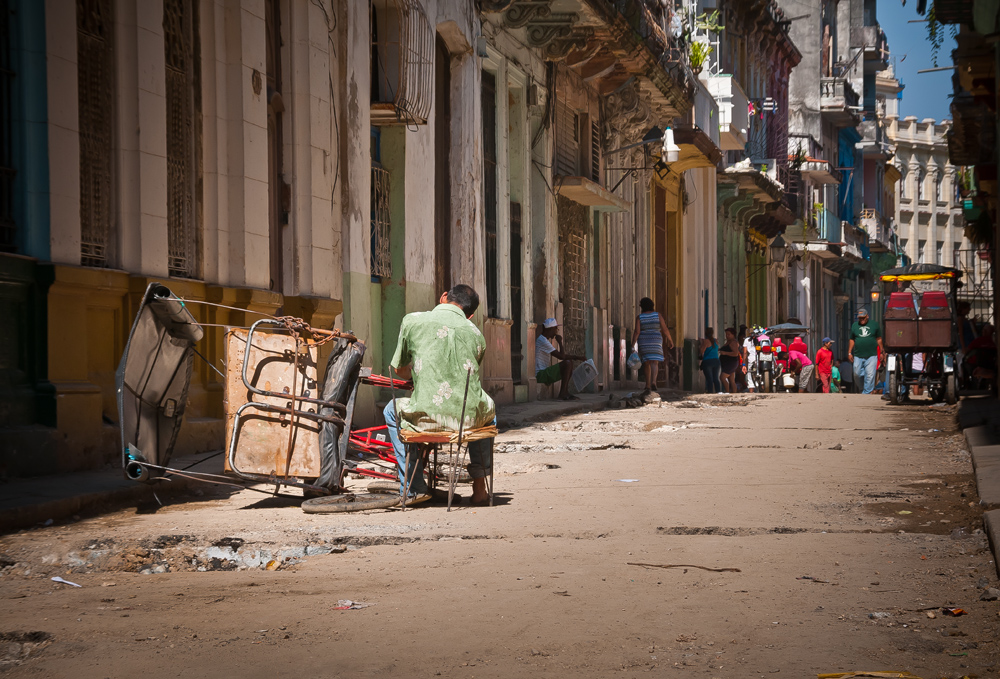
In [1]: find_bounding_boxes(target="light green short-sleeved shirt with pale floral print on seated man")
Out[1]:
[391,304,496,431]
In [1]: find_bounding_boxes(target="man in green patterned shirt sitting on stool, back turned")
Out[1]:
[383,285,496,504]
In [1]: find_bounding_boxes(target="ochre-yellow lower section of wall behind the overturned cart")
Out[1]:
[40,265,343,471]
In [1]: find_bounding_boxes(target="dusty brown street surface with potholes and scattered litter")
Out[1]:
[0,394,1000,679]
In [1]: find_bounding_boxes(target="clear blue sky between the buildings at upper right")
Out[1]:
[878,0,955,120]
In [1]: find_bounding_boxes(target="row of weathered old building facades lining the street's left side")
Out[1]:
[0,0,962,474]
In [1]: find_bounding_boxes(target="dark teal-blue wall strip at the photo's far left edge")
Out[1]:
[8,0,49,260]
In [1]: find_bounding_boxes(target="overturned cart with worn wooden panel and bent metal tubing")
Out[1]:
[116,283,365,504]
